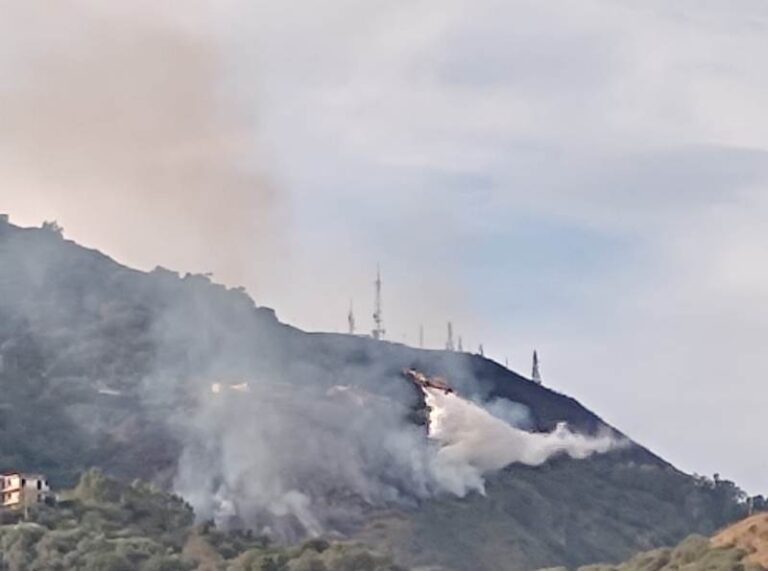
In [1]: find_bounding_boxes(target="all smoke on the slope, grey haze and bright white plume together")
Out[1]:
[176,376,622,539]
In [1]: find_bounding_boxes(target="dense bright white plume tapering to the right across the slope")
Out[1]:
[424,388,627,496]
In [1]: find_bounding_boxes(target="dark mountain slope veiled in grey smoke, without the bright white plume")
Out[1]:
[0,217,756,571]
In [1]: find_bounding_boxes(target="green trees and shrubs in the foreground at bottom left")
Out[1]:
[0,470,402,571]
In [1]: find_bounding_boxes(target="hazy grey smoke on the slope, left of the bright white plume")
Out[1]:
[175,384,439,539]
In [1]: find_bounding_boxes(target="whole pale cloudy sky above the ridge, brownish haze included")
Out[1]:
[0,0,768,492]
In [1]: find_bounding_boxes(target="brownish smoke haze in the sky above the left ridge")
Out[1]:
[0,0,283,289]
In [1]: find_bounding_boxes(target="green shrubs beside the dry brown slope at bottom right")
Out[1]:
[542,535,764,571]
